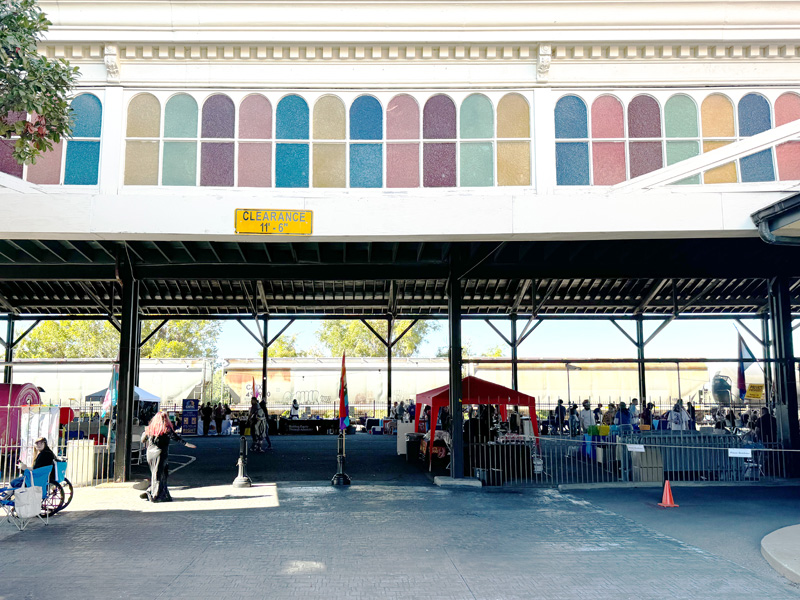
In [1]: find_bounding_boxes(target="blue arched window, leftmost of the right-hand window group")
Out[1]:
[555,96,589,185]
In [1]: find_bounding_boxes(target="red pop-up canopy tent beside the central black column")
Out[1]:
[414,377,539,437]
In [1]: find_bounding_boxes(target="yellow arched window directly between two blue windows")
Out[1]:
[313,96,347,187]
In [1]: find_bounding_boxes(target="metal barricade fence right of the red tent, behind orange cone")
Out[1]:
[462,432,800,487]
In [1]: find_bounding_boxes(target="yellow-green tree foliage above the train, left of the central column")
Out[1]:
[316,320,439,356]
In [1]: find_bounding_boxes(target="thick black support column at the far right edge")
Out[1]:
[769,277,800,454]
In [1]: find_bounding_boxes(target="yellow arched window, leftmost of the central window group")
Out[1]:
[125,94,161,185]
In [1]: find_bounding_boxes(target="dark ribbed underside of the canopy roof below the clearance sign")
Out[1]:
[0,238,800,318]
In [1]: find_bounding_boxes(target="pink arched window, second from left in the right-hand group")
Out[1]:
[592,96,627,185]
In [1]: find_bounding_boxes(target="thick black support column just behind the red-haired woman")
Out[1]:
[114,260,139,481]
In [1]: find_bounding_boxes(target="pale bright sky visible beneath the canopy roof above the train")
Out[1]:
[218,319,784,359]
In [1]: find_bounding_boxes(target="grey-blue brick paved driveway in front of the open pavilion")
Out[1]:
[0,436,800,600]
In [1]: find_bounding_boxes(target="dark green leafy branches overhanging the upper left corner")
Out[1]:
[0,0,78,163]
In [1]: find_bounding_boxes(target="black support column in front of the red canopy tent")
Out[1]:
[446,269,464,479]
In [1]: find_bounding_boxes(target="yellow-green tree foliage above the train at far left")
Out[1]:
[15,321,222,358]
